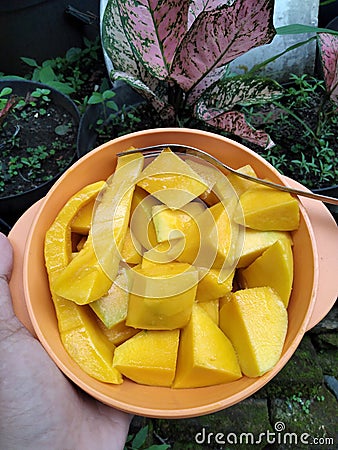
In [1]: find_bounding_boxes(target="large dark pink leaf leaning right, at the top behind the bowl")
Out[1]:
[171,0,275,91]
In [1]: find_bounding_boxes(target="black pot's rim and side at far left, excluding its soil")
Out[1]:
[0,79,80,226]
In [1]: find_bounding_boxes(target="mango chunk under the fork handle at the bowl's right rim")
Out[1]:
[234,187,299,231]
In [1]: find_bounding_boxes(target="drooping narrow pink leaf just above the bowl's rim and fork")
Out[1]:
[195,103,274,148]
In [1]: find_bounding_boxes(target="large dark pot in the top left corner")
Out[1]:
[0,0,100,75]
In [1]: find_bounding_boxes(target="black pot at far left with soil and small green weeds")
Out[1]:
[0,79,79,224]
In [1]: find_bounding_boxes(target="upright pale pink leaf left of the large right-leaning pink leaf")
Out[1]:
[118,0,189,80]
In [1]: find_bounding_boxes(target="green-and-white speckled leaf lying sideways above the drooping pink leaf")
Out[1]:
[198,75,283,111]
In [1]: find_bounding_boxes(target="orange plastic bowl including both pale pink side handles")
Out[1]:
[10,129,337,418]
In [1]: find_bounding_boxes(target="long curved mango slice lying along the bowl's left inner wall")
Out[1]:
[44,182,122,384]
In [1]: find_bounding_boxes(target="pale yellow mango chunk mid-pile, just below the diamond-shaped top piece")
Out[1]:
[152,202,205,242]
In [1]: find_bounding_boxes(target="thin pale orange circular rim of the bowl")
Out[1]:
[23,128,318,418]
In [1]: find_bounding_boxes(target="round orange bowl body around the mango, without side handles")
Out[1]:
[19,128,318,418]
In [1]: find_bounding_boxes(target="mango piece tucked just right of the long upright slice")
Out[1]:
[130,186,160,249]
